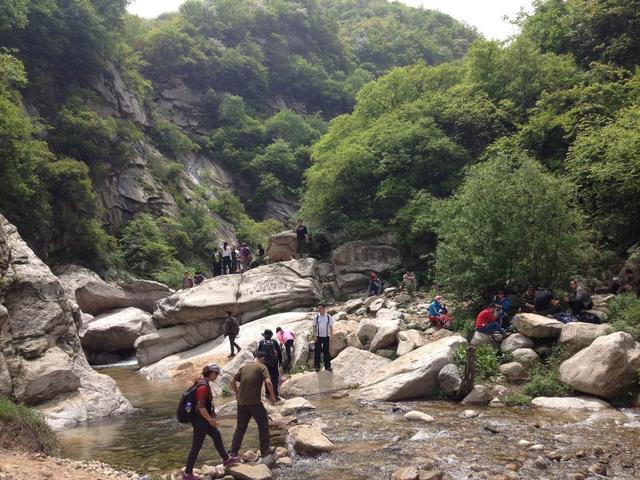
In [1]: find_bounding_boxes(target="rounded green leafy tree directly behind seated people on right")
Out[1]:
[436,147,587,294]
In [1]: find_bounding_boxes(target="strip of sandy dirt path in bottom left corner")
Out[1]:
[0,450,138,480]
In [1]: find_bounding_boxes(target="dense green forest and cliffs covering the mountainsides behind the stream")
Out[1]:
[0,0,640,293]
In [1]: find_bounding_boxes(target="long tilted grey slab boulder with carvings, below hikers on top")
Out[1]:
[153,258,322,327]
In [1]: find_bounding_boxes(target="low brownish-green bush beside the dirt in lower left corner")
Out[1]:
[0,396,58,454]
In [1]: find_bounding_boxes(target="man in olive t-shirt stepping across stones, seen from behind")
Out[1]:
[231,351,276,463]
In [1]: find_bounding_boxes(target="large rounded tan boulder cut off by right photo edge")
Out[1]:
[560,332,640,399]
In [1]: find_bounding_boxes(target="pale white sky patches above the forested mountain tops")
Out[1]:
[129,0,532,40]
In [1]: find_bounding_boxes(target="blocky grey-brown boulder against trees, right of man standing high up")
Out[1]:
[331,241,401,274]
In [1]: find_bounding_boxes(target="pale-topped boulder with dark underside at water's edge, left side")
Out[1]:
[80,307,156,352]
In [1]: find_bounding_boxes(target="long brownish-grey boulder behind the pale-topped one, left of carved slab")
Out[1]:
[76,281,171,315]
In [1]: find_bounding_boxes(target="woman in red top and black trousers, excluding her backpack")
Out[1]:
[182,363,240,480]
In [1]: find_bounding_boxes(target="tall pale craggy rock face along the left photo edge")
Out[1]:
[0,215,132,429]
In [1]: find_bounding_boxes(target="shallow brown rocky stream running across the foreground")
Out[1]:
[59,368,640,480]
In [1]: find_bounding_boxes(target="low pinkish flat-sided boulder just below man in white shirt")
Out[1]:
[281,347,391,396]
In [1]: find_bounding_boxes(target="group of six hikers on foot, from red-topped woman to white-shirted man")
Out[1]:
[177,304,333,480]
